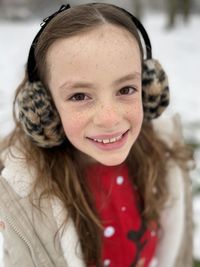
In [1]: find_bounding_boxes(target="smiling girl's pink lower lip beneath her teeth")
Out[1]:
[88,131,129,151]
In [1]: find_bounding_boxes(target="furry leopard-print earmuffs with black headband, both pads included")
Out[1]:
[16,3,169,148]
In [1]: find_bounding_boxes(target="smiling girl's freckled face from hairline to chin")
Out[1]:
[47,24,143,166]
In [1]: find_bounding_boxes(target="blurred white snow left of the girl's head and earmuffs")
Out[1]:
[0,22,38,136]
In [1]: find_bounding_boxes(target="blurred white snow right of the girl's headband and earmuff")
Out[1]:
[144,13,200,123]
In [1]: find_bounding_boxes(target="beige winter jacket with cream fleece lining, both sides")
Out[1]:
[0,115,192,267]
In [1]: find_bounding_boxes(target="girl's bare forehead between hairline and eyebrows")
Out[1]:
[47,24,141,86]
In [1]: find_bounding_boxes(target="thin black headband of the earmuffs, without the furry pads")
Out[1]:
[27,3,152,83]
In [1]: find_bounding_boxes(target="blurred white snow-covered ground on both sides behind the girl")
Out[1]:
[0,14,200,266]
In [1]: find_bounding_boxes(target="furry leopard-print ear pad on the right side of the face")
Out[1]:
[142,59,169,120]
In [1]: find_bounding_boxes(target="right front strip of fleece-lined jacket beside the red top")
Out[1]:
[154,162,193,267]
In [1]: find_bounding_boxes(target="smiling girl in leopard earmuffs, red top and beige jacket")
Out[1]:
[0,3,192,267]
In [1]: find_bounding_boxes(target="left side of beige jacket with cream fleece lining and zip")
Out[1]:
[0,149,84,267]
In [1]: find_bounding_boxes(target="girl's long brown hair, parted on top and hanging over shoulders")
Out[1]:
[0,4,194,266]
